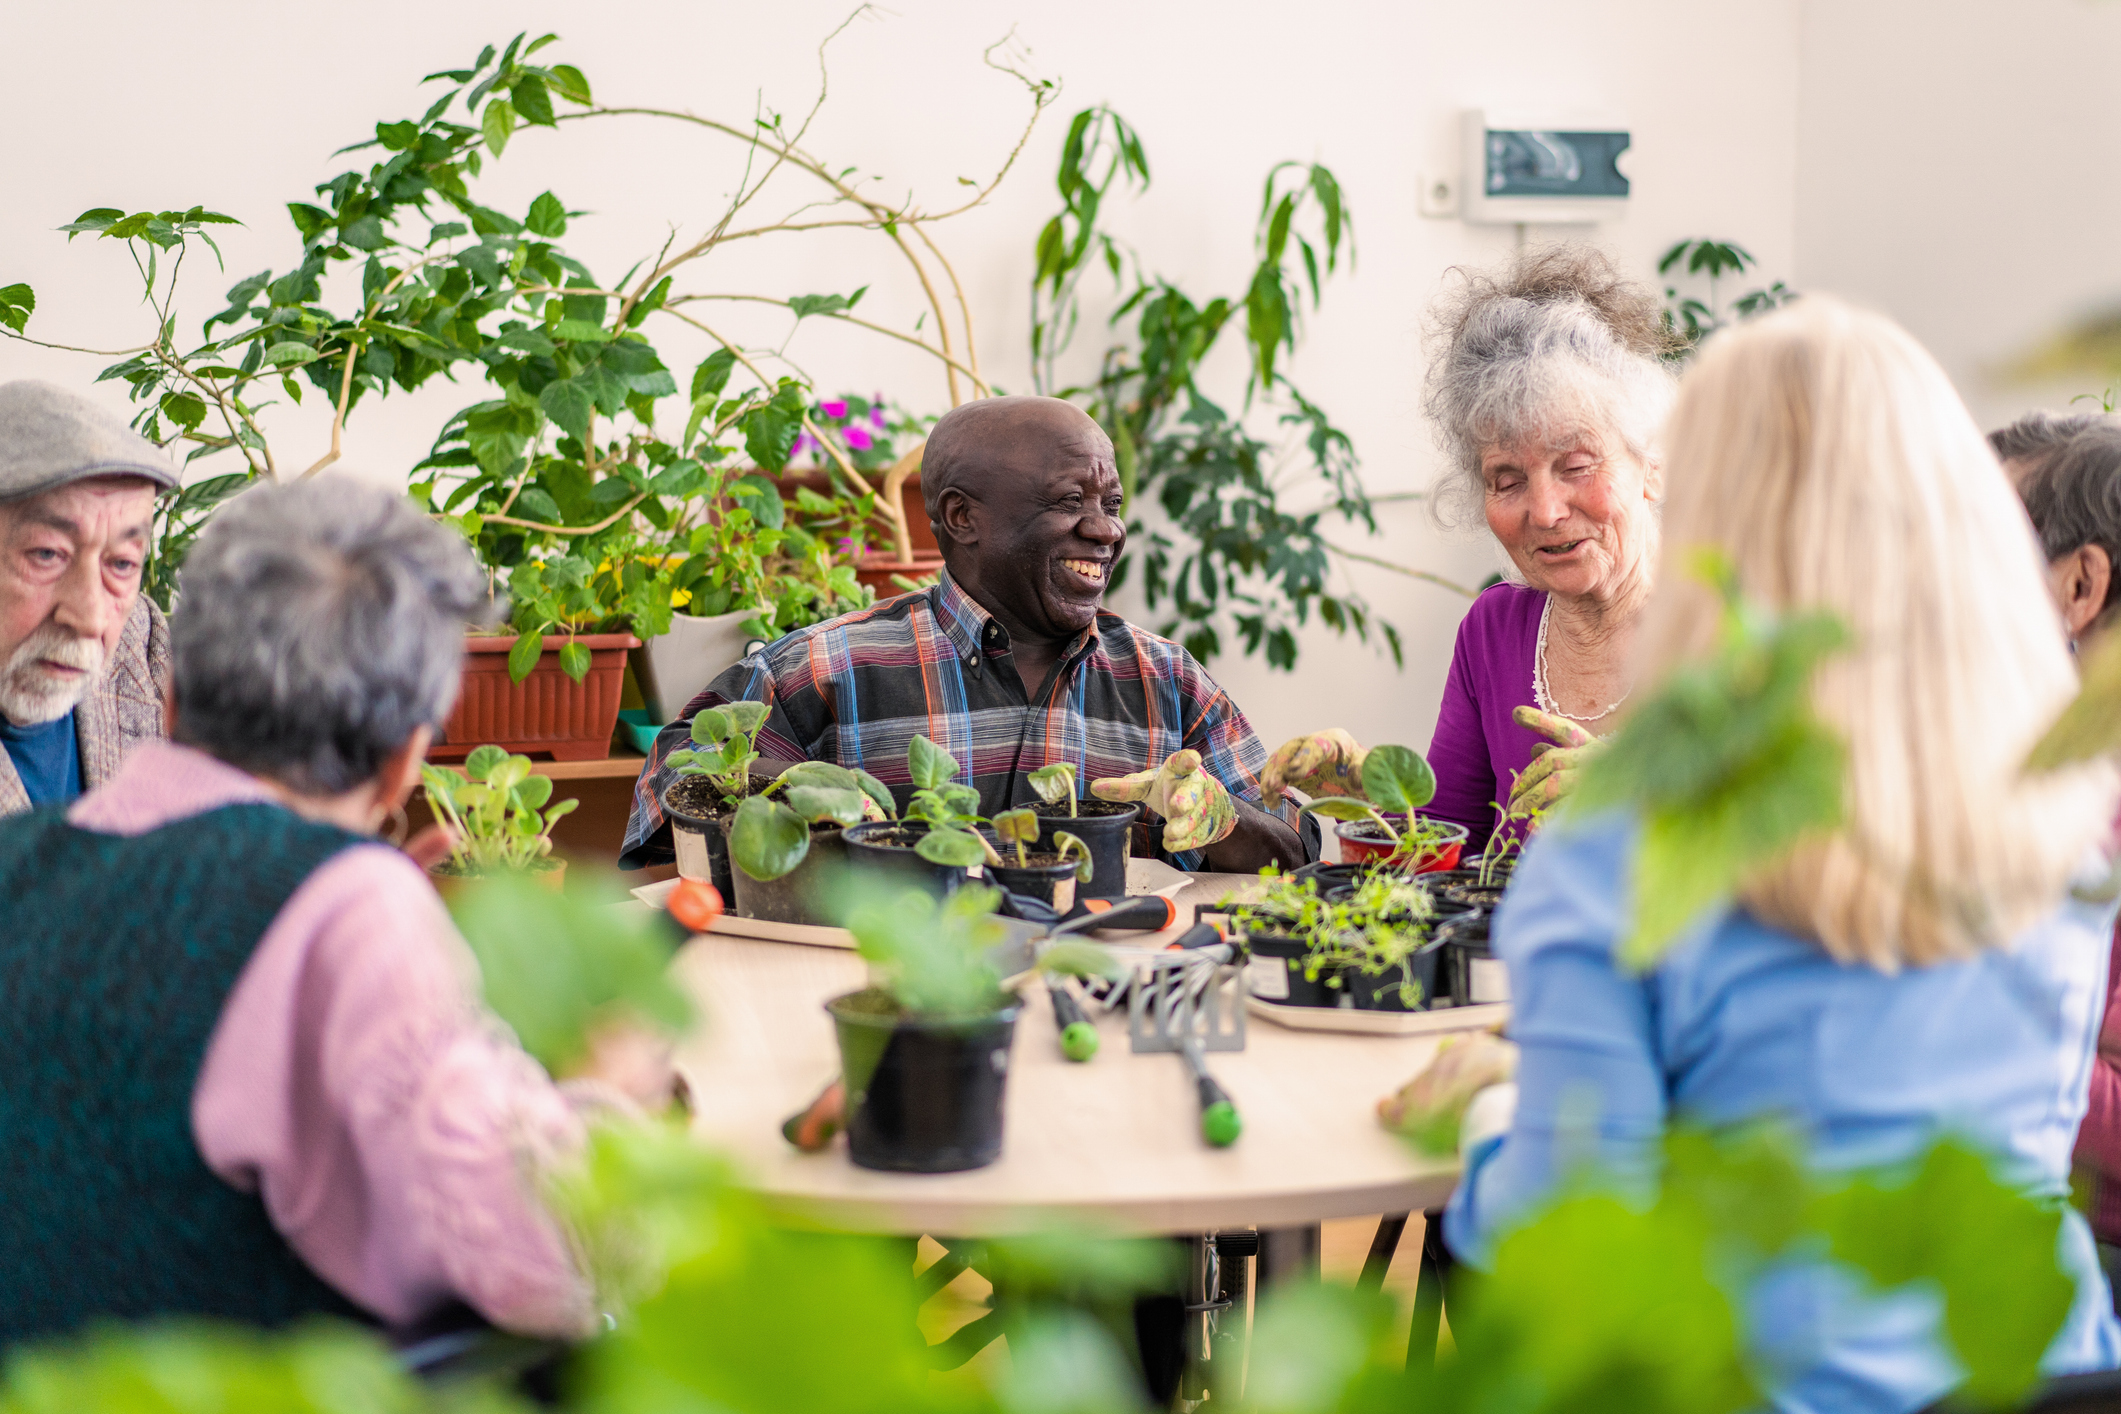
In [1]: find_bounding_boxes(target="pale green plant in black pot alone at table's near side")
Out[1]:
[825,886,1111,1172]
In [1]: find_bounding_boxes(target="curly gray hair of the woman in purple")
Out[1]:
[1423,244,1678,528]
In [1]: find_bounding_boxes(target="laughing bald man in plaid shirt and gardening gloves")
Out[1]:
[621,396,1304,871]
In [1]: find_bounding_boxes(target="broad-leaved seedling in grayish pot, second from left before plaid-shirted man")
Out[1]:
[723,761,891,924]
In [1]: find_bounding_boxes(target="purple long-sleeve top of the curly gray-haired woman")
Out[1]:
[1423,583,1546,856]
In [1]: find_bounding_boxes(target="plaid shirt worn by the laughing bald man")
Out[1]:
[619,572,1287,869]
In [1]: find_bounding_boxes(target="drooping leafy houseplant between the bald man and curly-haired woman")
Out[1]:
[1031,106,1472,670]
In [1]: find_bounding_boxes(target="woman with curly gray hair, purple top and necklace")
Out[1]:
[1425,246,1676,850]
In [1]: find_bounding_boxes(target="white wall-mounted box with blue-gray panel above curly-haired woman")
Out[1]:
[1459,108,1629,225]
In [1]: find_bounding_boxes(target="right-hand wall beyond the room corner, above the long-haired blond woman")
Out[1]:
[1796,0,2121,428]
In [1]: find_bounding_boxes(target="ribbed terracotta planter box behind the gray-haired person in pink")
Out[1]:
[426,634,641,761]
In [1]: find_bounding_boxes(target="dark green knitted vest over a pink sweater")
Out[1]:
[0,806,373,1346]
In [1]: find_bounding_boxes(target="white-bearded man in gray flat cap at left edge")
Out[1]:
[0,379,178,816]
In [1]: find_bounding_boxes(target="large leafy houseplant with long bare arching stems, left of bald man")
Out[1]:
[0,25,1052,678]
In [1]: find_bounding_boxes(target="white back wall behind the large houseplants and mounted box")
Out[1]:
[0,0,1790,746]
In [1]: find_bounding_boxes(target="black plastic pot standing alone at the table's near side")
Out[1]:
[825,990,1018,1174]
